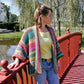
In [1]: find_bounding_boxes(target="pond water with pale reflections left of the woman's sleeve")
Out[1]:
[0,39,20,68]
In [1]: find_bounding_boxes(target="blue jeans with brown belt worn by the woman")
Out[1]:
[34,61,59,84]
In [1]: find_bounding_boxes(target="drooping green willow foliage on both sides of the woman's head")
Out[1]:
[11,0,84,29]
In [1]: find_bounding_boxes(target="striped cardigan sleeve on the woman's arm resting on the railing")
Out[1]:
[12,30,29,61]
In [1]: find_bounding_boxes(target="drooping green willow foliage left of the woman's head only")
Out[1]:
[15,0,39,29]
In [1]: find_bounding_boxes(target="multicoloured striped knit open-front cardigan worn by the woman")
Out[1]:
[13,26,64,74]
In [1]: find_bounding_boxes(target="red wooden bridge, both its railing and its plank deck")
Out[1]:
[0,29,84,84]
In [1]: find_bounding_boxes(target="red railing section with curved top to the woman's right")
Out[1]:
[57,31,82,79]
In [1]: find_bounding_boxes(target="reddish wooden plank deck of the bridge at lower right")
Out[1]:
[61,52,84,84]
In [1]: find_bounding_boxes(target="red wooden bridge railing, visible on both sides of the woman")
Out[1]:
[0,29,82,84]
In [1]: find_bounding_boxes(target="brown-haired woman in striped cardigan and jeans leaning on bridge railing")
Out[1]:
[10,5,63,84]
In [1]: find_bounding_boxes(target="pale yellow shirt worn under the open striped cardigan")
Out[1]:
[39,32,52,59]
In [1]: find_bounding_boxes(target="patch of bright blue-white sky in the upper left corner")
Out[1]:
[0,0,19,16]
